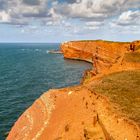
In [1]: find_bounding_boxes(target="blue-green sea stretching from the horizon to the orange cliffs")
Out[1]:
[0,44,91,140]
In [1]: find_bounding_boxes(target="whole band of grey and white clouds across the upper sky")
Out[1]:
[0,0,140,33]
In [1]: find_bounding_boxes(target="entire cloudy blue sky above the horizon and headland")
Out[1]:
[0,0,140,42]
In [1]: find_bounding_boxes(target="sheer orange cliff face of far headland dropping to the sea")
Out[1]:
[61,40,130,73]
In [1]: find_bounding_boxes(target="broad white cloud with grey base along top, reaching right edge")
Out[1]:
[52,0,140,20]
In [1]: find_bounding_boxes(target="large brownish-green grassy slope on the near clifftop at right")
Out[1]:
[91,70,140,125]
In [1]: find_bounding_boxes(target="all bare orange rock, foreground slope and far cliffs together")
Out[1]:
[7,40,140,140]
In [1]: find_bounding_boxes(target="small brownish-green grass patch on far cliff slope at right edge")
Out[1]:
[124,52,140,62]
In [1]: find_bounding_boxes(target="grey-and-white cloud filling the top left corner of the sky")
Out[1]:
[0,0,49,23]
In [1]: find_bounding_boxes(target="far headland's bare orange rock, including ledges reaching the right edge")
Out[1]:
[61,40,140,74]
